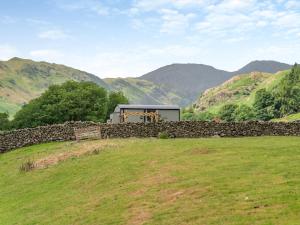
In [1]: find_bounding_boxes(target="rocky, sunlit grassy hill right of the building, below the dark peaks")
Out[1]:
[195,71,288,113]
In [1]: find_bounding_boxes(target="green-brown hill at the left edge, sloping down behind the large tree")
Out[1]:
[0,58,109,115]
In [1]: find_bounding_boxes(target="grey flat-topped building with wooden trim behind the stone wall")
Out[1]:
[108,105,180,123]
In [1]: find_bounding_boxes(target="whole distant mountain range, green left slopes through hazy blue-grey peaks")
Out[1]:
[0,58,291,116]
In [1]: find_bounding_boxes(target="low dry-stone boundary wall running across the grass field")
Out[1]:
[0,121,300,153]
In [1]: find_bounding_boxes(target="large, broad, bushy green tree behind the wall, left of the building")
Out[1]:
[13,81,108,128]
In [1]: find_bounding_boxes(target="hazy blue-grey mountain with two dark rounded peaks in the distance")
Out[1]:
[140,61,291,101]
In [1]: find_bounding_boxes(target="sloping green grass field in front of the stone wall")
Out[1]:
[0,137,300,225]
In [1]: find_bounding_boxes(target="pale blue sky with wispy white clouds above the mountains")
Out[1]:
[0,0,300,78]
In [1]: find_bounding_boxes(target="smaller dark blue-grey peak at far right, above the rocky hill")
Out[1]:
[234,60,291,75]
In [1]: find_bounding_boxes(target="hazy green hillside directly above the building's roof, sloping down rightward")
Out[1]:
[104,78,188,105]
